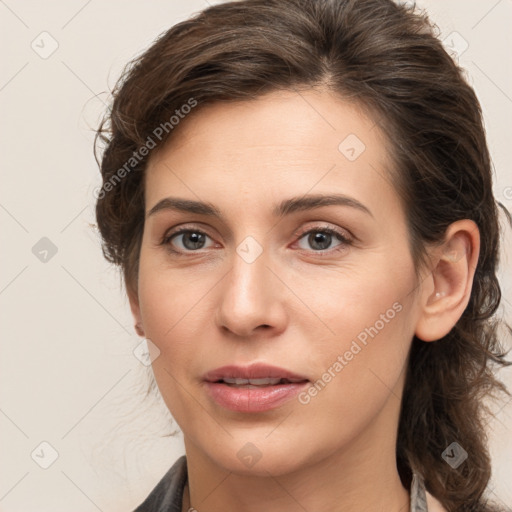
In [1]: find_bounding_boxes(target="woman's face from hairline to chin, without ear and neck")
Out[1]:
[131,90,426,475]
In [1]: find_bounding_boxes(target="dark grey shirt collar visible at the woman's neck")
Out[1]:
[134,455,428,512]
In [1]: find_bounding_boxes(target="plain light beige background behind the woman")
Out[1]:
[0,0,512,512]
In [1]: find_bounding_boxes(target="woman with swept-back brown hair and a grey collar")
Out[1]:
[97,0,509,512]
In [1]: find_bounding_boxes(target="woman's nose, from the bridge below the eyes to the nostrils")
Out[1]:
[216,245,288,338]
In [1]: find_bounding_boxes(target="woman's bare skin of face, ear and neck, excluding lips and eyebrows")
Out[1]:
[129,90,479,512]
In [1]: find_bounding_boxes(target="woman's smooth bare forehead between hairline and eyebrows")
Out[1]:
[146,90,396,214]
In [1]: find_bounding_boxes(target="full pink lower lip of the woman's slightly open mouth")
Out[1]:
[206,381,308,412]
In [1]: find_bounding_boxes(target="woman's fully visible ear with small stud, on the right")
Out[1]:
[415,219,480,341]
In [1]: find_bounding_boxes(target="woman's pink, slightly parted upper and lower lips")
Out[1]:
[204,364,309,413]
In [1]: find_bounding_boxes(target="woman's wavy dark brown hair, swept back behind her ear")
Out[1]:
[96,0,510,511]
